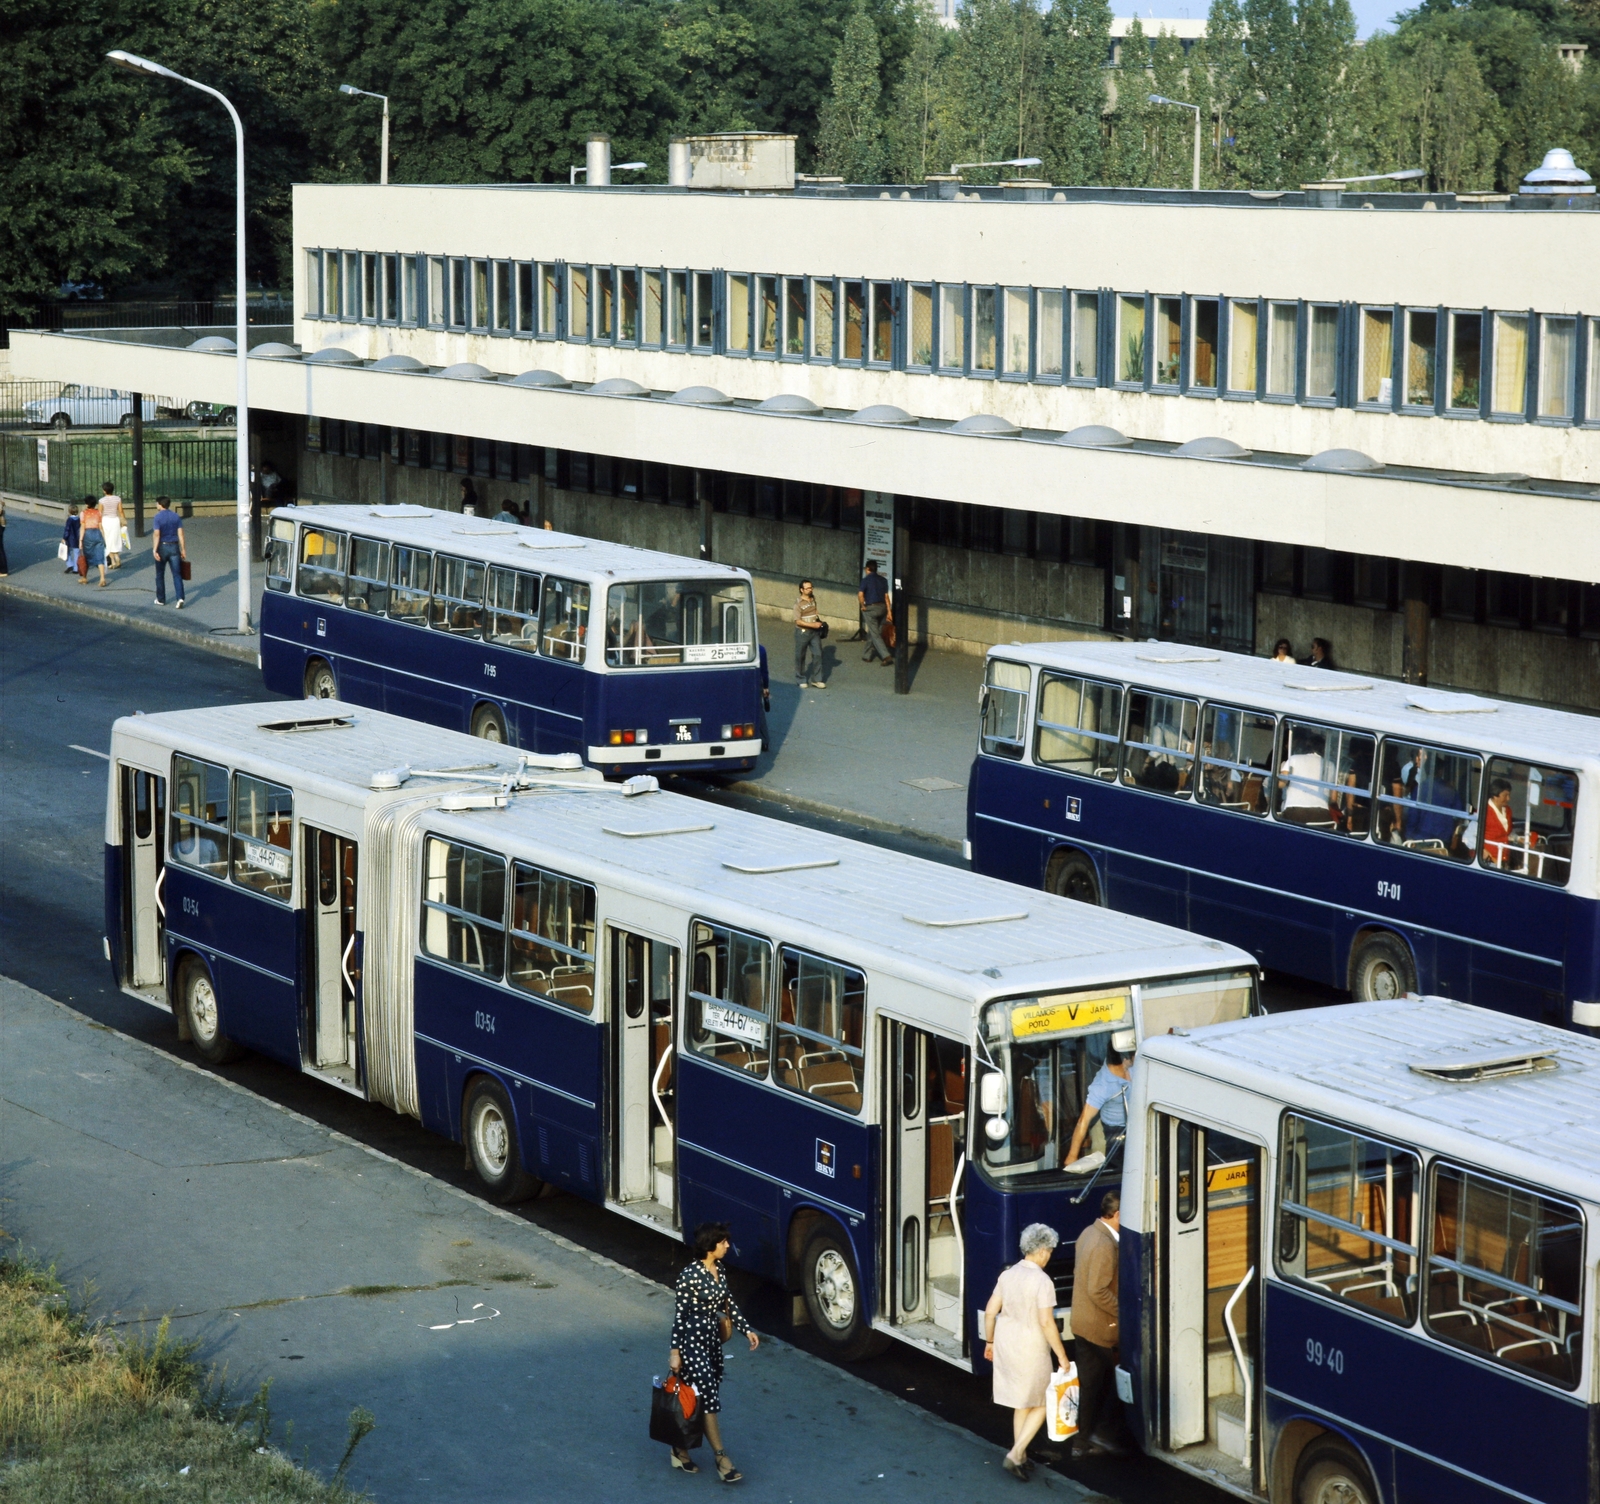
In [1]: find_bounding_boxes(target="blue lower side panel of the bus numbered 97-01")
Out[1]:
[968,757,1574,1022]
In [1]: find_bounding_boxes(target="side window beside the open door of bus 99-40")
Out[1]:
[1277,1112,1421,1326]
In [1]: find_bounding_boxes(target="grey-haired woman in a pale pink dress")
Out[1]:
[984,1222,1067,1483]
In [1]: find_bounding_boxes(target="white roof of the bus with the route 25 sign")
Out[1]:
[272,506,750,584]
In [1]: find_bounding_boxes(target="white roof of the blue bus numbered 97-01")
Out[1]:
[989,642,1600,771]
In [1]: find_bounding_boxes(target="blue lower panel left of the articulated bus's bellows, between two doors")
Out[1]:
[162,862,304,1070]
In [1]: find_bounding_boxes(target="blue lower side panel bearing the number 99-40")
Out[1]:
[1262,1280,1590,1504]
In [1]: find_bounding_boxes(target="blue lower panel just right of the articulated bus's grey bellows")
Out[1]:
[414,957,605,1200]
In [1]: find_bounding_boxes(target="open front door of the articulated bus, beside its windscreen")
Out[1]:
[882,1019,970,1358]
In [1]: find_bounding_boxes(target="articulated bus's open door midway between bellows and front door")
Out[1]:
[611,928,678,1227]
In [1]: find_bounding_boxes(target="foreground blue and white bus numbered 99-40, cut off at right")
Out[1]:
[1117,997,1600,1504]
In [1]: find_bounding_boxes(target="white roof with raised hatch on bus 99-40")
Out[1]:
[1141,997,1600,1200]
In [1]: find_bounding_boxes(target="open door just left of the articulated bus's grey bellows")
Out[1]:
[302,826,363,1091]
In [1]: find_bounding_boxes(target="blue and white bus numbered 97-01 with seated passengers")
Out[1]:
[966,642,1600,1027]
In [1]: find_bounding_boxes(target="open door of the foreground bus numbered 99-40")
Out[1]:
[1158,1115,1261,1488]
